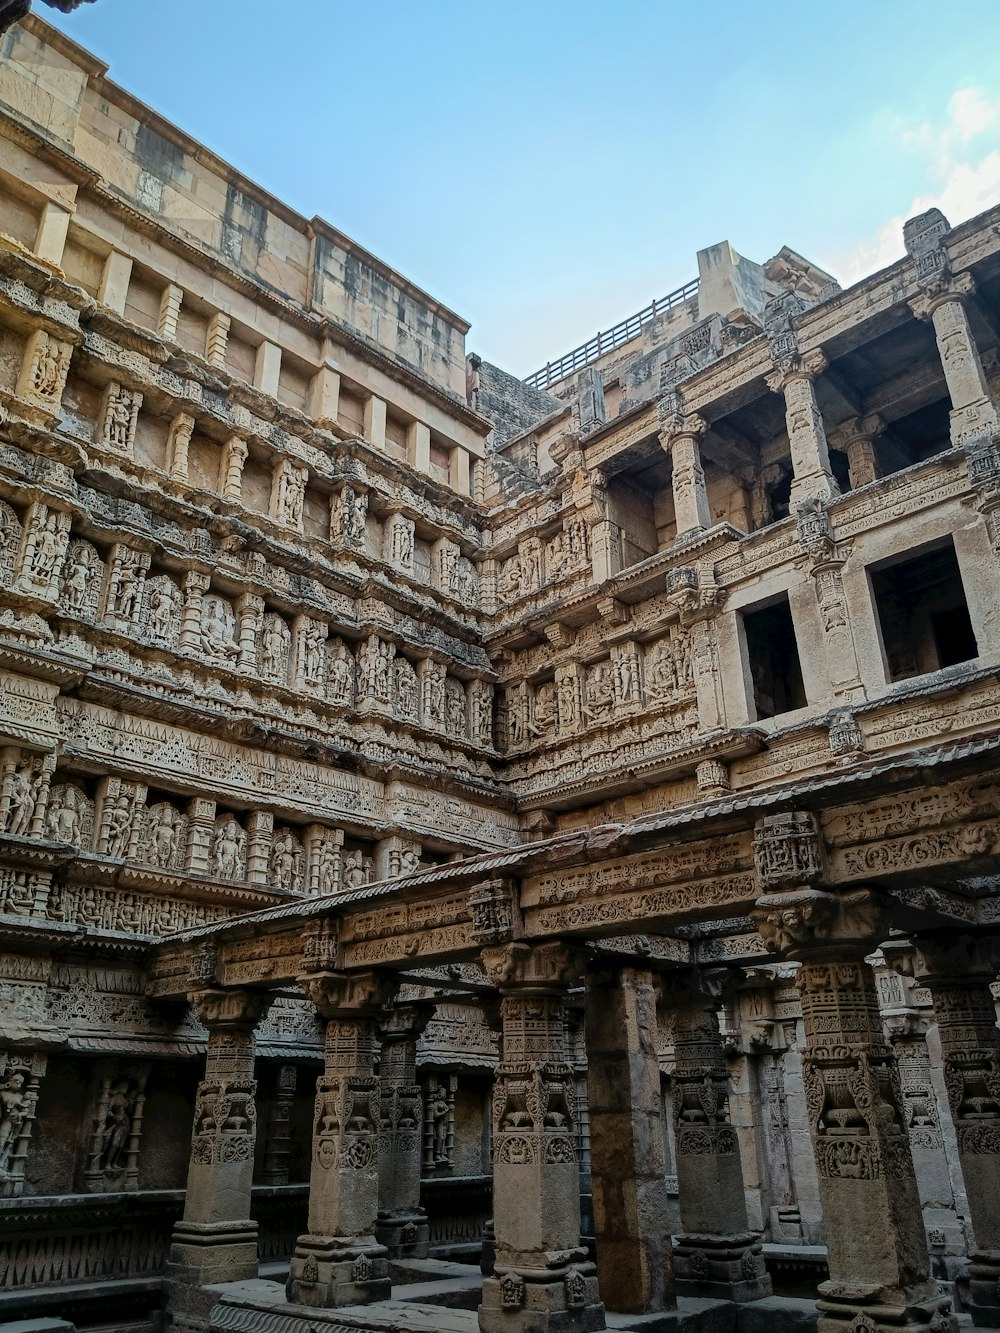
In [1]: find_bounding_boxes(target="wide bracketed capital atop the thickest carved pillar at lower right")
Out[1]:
[751,888,885,961]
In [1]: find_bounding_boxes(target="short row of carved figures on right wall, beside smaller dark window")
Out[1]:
[499,625,697,754]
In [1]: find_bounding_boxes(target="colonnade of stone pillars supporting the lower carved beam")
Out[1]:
[162,886,1000,1333]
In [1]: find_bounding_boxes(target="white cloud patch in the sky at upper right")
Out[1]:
[831,88,1000,285]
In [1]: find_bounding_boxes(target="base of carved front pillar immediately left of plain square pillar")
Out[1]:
[479,1250,607,1333]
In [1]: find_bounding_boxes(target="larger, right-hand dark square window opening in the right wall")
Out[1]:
[871,540,979,681]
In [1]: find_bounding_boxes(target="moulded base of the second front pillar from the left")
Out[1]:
[285,1236,392,1310]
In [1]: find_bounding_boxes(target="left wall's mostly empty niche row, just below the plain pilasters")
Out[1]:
[0,329,480,611]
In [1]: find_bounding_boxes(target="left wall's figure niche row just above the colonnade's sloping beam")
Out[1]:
[0,746,440,894]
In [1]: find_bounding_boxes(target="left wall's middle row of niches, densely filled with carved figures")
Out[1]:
[0,501,493,746]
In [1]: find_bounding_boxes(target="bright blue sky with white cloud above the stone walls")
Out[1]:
[43,0,1000,375]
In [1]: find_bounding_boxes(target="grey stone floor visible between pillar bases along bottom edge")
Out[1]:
[201,1260,997,1333]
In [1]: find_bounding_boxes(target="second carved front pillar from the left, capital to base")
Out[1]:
[288,972,392,1309]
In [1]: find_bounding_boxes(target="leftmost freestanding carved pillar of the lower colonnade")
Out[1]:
[167,990,268,1328]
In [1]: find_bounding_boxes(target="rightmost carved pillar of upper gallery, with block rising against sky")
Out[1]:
[903,208,1000,444]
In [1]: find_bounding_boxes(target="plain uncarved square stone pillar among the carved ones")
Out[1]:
[585,966,675,1314]
